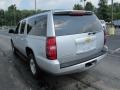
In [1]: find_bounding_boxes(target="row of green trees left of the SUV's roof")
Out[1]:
[0,4,41,26]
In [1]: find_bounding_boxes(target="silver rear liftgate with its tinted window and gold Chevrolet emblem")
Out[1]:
[54,14,104,63]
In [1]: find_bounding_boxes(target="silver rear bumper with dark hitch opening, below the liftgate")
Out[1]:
[36,47,107,75]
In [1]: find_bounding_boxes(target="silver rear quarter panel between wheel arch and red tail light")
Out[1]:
[27,35,46,58]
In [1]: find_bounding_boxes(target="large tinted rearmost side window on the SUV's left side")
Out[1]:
[27,15,47,36]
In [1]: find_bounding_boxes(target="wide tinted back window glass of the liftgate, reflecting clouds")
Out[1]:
[54,15,102,36]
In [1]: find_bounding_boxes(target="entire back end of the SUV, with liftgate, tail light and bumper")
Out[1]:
[37,11,107,75]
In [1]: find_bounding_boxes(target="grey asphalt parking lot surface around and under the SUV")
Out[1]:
[0,29,120,90]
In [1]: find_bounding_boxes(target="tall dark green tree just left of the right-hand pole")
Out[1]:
[97,0,111,21]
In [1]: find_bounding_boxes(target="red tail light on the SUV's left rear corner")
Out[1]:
[46,37,57,60]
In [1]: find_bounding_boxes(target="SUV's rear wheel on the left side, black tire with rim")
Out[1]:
[28,53,40,78]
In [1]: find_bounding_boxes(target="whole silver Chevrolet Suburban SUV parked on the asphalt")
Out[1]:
[9,10,107,76]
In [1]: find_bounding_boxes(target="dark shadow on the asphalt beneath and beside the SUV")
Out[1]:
[9,52,93,90]
